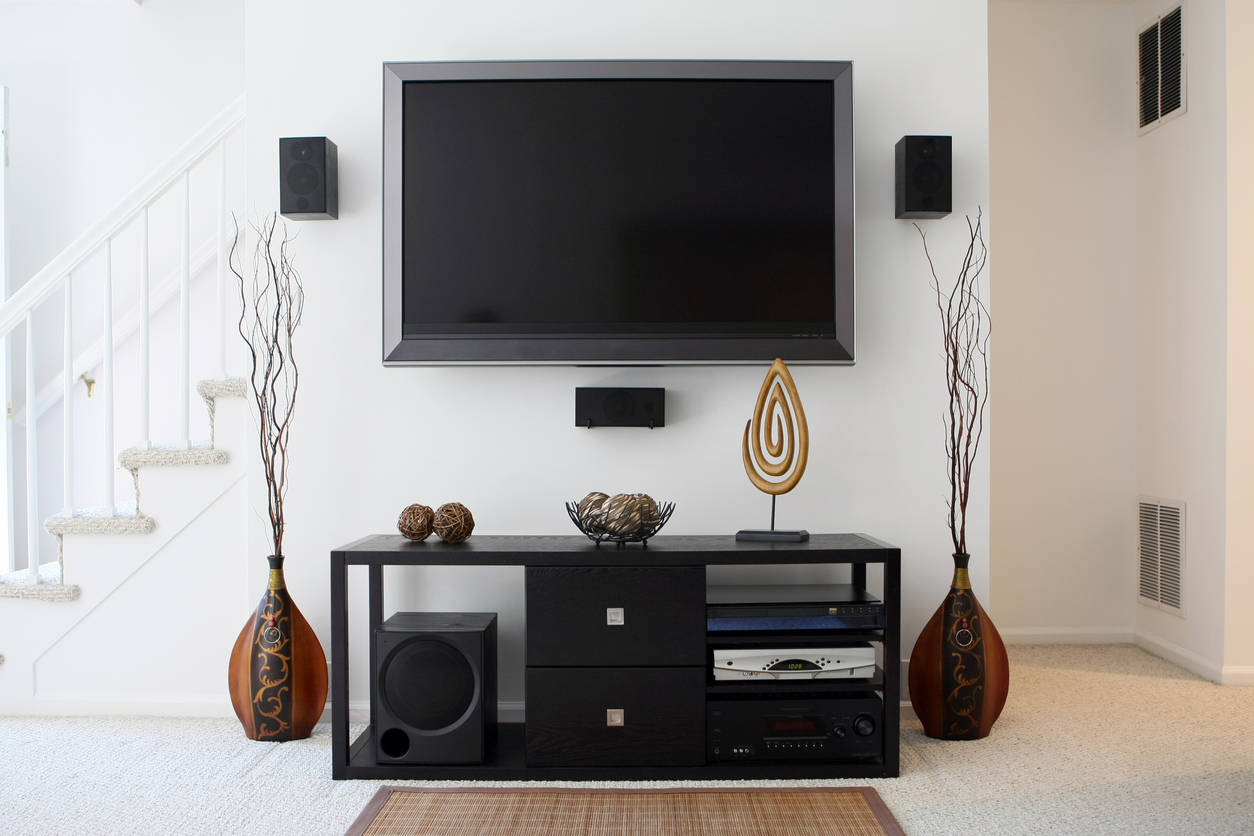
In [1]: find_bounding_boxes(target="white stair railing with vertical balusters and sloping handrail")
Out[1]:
[0,95,246,584]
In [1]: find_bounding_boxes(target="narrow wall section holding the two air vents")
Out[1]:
[1134,0,1229,681]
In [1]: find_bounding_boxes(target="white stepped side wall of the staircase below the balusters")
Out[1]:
[0,397,252,717]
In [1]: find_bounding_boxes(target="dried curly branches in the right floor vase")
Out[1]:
[914,211,992,554]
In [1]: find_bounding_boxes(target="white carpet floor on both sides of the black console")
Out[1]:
[0,645,1254,836]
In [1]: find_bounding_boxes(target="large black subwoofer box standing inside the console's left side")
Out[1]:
[371,613,497,763]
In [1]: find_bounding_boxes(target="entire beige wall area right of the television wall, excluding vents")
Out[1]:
[989,0,1254,683]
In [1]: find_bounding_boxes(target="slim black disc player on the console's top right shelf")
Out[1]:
[706,584,884,632]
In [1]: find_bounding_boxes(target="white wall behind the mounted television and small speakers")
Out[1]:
[241,0,1001,702]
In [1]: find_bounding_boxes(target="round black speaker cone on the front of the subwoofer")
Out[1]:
[382,639,475,732]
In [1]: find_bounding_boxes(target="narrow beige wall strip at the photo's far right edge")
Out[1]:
[1224,0,1254,684]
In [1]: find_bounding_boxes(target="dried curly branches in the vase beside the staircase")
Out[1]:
[231,214,305,556]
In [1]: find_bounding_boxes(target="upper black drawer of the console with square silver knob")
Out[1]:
[527,567,706,667]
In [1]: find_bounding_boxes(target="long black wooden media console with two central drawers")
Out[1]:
[331,534,902,781]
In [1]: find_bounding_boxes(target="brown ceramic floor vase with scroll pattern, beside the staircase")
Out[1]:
[228,555,326,741]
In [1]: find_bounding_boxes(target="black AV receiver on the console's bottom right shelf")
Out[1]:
[706,694,884,762]
